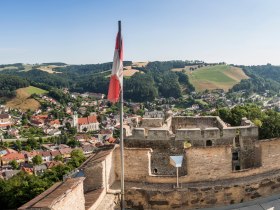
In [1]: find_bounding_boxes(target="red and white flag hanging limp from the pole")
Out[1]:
[108,32,123,103]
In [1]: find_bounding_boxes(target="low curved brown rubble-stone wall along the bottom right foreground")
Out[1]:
[126,171,280,209]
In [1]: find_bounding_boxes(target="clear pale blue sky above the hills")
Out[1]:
[0,0,280,65]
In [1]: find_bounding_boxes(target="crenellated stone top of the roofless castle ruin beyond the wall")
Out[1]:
[127,116,258,146]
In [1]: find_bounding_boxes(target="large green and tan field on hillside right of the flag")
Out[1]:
[186,65,249,91]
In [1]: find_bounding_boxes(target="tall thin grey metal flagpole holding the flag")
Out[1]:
[118,20,125,210]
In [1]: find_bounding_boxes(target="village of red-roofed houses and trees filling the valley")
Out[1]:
[0,89,280,179]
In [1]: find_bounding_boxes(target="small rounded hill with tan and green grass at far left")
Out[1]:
[6,86,47,110]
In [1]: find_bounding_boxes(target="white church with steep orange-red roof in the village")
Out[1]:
[73,113,99,132]
